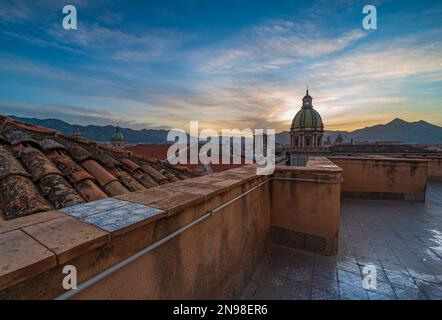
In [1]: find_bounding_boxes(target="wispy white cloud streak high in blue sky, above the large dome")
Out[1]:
[194,20,367,73]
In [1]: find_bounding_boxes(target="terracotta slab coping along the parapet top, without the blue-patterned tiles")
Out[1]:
[0,158,342,298]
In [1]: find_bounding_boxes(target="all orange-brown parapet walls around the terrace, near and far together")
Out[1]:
[0,157,428,299]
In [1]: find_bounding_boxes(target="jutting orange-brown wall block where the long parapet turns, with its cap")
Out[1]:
[271,158,342,255]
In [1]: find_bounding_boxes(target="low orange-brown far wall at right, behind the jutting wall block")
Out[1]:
[329,157,428,202]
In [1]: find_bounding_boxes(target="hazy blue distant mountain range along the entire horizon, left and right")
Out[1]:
[6,116,442,144]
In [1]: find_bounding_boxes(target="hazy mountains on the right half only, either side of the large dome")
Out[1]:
[276,118,442,144]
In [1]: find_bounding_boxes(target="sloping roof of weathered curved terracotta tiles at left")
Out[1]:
[0,115,200,219]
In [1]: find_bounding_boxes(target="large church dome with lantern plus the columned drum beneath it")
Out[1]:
[290,87,324,149]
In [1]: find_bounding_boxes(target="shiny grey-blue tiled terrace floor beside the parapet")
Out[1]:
[243,183,442,300]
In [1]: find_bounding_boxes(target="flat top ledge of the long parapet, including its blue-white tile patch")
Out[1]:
[0,158,342,298]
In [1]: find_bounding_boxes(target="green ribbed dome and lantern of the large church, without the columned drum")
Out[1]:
[291,90,324,131]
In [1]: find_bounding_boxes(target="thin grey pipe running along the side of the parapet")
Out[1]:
[55,177,342,300]
